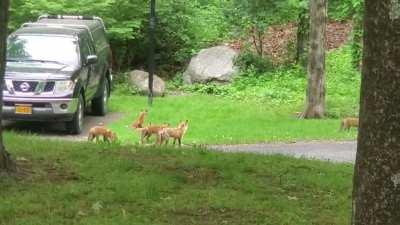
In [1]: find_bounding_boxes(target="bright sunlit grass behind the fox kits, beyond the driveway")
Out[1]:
[110,95,356,144]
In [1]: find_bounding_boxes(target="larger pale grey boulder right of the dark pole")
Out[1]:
[183,46,239,84]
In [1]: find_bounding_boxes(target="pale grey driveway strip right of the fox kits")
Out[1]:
[209,141,357,163]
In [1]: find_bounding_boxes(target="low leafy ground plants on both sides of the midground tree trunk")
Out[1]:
[177,46,361,118]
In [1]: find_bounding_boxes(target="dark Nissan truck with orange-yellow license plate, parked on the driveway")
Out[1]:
[3,16,112,134]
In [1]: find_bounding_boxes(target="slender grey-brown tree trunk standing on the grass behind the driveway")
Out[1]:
[302,0,327,118]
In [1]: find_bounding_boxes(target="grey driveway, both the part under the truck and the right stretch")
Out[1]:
[3,112,357,163]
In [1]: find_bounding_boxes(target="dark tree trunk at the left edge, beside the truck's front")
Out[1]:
[0,0,15,172]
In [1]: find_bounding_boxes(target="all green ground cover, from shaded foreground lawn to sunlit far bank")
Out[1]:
[0,45,359,225]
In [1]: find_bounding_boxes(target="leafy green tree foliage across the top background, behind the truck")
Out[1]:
[10,0,362,77]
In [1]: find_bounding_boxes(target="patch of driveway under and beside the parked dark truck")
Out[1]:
[3,112,124,141]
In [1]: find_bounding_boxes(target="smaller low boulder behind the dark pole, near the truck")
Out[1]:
[128,70,165,96]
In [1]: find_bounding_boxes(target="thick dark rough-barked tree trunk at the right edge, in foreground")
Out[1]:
[352,0,400,225]
